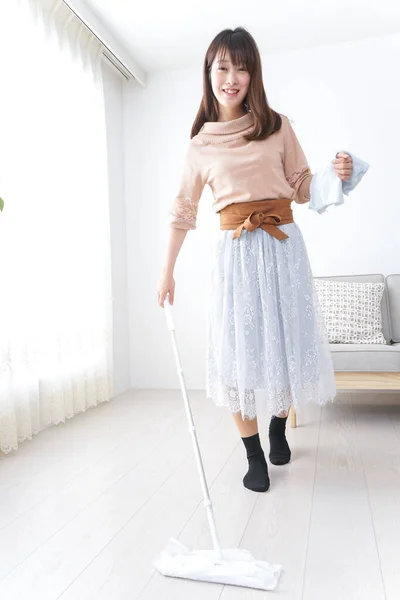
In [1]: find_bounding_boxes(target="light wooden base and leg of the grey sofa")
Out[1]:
[290,371,400,427]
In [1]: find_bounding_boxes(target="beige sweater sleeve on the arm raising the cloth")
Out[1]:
[282,115,312,204]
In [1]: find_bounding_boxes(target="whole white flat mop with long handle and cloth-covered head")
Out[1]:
[154,298,282,590]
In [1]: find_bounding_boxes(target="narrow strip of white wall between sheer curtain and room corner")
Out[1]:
[102,60,131,396]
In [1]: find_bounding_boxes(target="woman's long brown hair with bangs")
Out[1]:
[190,27,282,141]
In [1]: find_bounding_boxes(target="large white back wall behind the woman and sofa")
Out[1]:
[124,35,400,388]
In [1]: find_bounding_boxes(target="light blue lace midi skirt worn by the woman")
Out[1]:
[206,223,336,419]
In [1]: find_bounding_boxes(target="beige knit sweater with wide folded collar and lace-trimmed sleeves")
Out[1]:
[169,113,312,229]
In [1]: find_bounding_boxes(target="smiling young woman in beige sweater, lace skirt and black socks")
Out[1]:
[158,27,352,492]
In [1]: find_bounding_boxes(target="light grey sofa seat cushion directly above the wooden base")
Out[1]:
[329,344,400,372]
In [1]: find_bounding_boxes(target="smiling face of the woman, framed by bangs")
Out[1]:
[211,51,250,111]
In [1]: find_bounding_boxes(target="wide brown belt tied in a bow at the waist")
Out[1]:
[219,199,294,240]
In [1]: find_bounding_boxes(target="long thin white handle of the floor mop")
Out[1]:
[164,298,223,562]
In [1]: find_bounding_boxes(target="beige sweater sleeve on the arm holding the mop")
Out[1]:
[168,142,206,229]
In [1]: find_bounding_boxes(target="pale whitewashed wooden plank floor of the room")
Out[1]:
[0,391,400,600]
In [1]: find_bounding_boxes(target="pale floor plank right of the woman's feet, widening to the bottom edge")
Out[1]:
[303,394,385,600]
